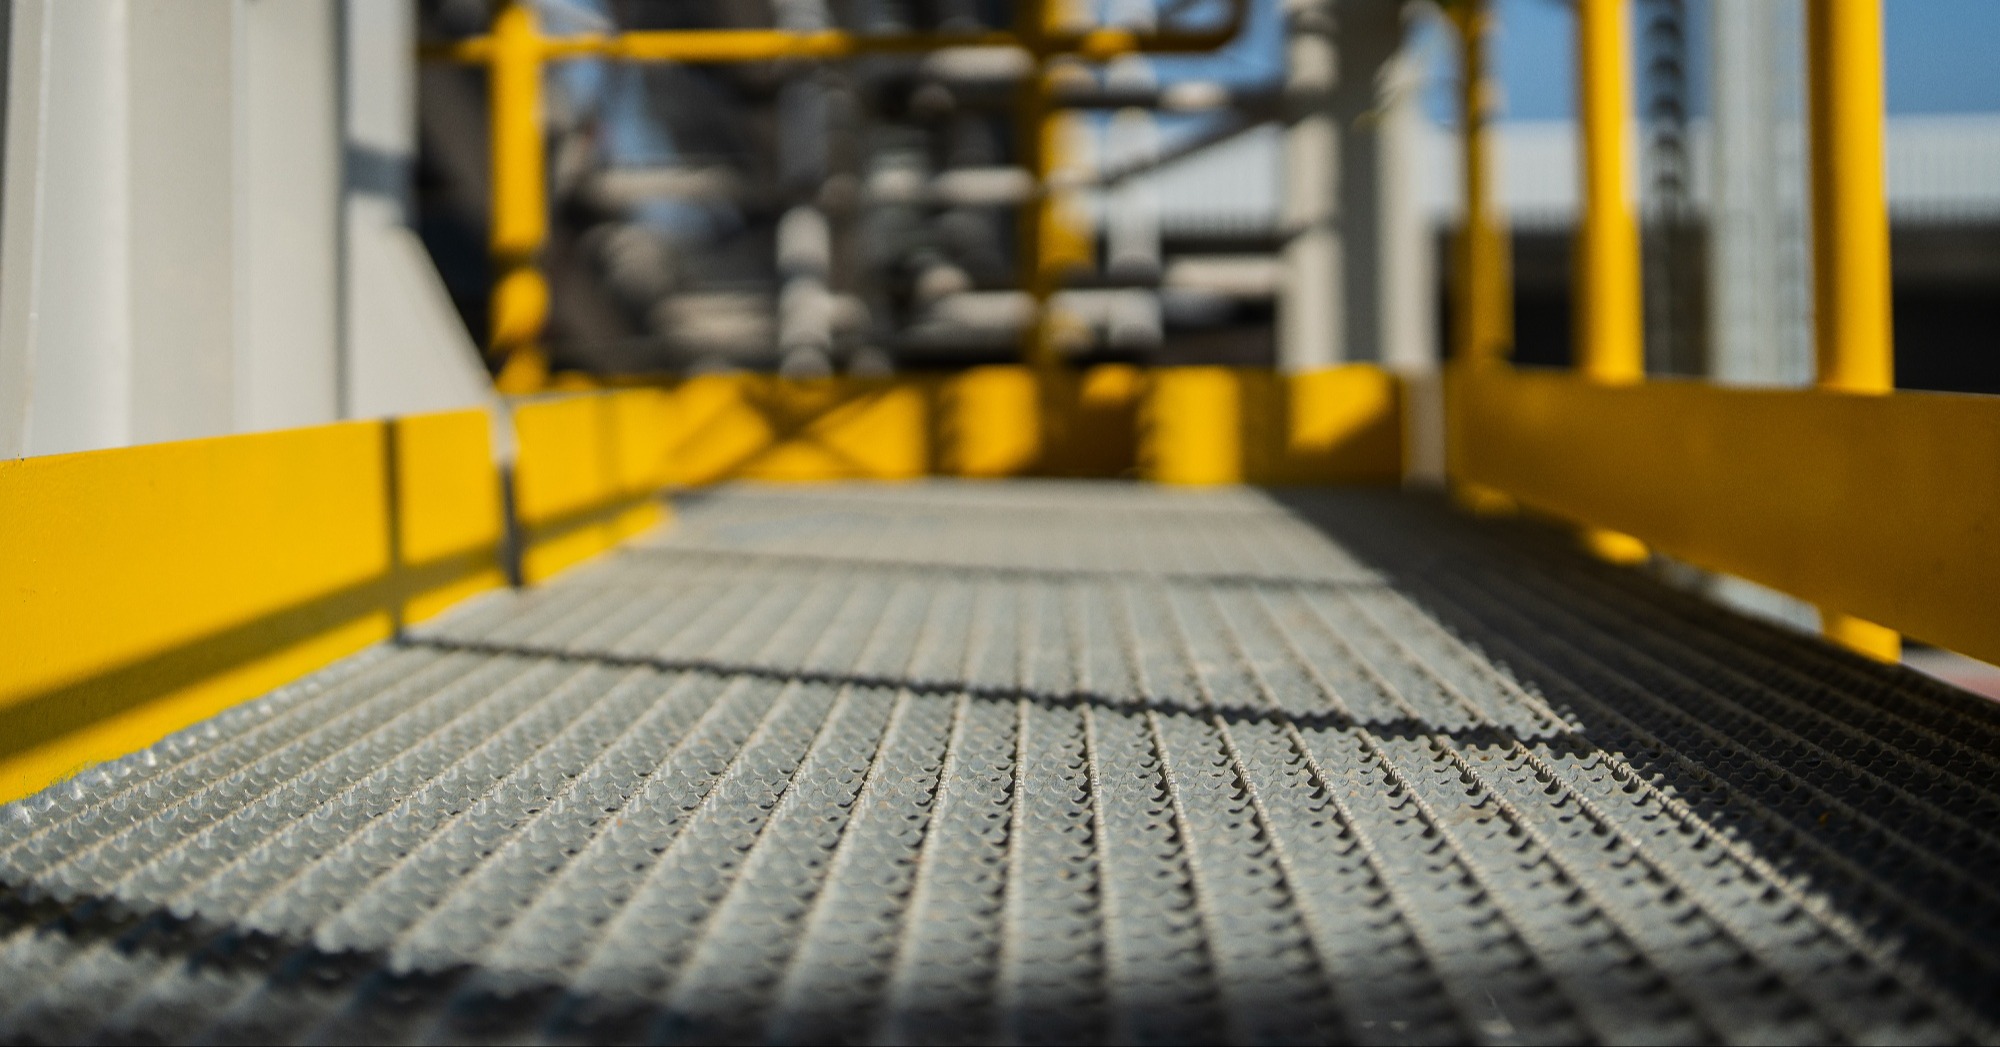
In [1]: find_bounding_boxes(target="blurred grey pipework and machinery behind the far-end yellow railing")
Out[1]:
[420,0,1436,376]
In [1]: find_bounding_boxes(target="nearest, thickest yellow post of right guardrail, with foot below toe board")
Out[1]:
[1806,0,1902,661]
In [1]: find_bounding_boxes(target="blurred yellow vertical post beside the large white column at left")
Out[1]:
[486,0,548,394]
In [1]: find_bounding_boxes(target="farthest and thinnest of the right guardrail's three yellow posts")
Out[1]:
[1450,0,1514,362]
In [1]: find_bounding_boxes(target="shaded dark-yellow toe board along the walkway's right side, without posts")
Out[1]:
[1448,368,2000,661]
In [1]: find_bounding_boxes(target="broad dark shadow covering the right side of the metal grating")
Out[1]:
[1272,492,2000,1021]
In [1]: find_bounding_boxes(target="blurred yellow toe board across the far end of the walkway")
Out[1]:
[580,364,1406,486]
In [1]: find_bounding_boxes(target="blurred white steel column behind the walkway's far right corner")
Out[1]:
[1278,0,1436,372]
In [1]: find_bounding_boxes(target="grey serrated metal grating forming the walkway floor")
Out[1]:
[0,484,2000,1043]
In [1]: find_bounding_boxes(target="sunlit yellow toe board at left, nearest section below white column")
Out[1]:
[0,412,504,799]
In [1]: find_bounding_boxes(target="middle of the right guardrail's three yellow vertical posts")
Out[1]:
[1574,0,1646,384]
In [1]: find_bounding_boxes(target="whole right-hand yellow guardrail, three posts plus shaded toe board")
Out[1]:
[1448,0,1928,659]
